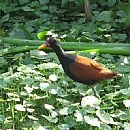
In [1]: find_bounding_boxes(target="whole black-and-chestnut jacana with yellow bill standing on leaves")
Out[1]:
[38,37,117,98]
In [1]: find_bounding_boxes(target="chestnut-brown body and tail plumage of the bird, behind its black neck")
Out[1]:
[69,56,117,85]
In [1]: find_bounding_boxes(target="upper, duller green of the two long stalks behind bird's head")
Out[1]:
[0,37,130,49]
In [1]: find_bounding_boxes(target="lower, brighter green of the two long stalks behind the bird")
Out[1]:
[0,46,130,55]
